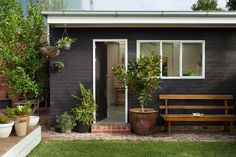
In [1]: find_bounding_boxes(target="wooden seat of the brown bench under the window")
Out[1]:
[161,114,236,122]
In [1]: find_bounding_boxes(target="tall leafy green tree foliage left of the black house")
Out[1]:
[0,0,48,97]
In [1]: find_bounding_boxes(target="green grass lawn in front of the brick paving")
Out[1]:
[29,141,236,157]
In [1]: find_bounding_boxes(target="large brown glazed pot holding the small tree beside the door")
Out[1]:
[129,108,158,135]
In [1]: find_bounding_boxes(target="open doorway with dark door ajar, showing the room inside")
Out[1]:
[93,40,127,123]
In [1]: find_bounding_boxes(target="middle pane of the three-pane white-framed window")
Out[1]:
[162,42,180,77]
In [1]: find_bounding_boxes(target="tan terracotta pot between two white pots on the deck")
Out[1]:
[15,116,30,136]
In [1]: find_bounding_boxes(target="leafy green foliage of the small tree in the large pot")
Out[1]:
[112,53,161,108]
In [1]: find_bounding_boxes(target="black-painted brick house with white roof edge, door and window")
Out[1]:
[43,11,236,123]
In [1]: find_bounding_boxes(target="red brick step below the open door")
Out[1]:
[91,123,131,133]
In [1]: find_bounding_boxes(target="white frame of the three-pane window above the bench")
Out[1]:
[136,40,205,79]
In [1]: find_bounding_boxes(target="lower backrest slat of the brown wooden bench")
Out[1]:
[160,105,234,110]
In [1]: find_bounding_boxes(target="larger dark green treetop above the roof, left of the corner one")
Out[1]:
[192,0,221,11]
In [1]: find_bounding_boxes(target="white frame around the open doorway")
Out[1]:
[93,39,128,123]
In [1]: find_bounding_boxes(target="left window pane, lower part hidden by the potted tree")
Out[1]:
[140,42,160,56]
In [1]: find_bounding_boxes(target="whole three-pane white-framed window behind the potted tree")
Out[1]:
[137,40,205,79]
